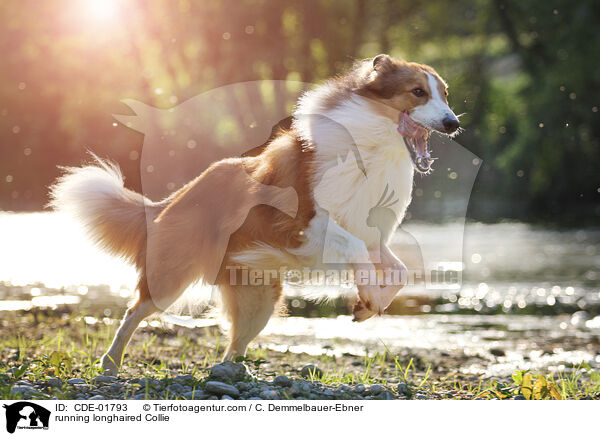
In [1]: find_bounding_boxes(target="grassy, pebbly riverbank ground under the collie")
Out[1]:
[0,311,600,400]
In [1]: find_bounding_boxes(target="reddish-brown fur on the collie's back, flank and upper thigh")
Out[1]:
[138,131,314,307]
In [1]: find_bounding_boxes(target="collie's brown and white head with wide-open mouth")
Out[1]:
[355,54,460,173]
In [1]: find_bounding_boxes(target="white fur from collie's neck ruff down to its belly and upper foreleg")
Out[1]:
[233,88,414,276]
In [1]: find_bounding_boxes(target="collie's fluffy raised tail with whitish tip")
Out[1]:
[49,156,159,266]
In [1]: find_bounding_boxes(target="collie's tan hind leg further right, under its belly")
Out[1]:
[219,282,281,360]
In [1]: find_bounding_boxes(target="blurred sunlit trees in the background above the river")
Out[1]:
[0,0,600,226]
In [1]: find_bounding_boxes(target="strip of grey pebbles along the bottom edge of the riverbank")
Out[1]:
[5,362,450,400]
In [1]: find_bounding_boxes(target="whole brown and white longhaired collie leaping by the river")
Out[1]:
[51,54,459,374]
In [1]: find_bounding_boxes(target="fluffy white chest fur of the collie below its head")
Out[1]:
[297,97,414,249]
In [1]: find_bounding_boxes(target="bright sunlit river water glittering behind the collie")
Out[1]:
[0,212,600,374]
